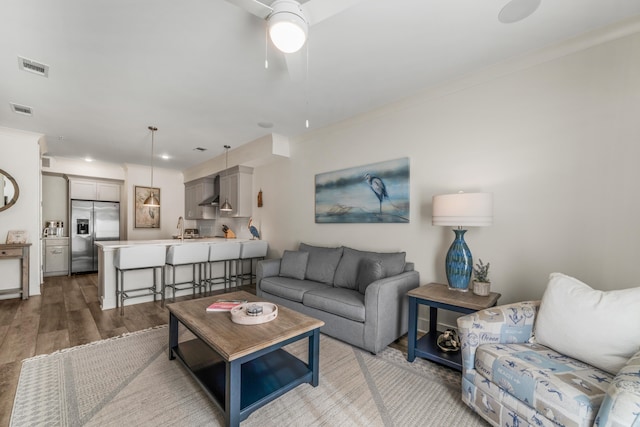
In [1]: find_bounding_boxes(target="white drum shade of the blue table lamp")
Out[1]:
[432,193,493,227]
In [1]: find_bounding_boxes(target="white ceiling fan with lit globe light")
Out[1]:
[227,0,362,80]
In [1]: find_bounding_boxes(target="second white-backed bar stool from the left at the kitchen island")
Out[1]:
[162,243,209,307]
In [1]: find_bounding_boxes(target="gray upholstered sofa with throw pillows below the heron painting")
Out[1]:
[256,243,420,354]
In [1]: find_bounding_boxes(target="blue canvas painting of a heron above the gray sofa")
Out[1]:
[315,158,410,223]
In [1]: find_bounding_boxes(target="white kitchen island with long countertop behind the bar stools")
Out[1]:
[95,237,255,310]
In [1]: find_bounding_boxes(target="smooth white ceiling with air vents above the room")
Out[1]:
[0,0,640,169]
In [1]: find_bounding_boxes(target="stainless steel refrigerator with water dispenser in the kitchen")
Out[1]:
[71,200,120,273]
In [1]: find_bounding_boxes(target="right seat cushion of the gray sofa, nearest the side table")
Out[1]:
[302,288,364,322]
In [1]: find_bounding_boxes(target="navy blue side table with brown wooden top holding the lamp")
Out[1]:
[407,283,501,371]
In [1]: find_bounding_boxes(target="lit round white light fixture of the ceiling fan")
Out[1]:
[268,0,308,53]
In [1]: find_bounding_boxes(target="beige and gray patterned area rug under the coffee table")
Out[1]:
[11,326,486,427]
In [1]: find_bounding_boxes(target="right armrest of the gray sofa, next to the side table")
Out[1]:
[364,271,420,354]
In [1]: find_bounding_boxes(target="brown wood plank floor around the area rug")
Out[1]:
[0,274,407,426]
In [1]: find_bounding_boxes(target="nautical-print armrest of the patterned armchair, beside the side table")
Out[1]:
[457,301,540,381]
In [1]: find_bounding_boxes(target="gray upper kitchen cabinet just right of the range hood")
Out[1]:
[220,166,253,218]
